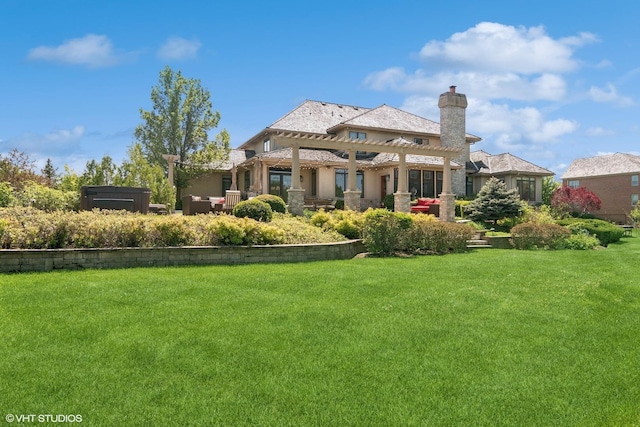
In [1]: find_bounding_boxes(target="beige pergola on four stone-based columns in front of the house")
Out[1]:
[272,132,462,221]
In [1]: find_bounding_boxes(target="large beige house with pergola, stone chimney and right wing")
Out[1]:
[187,86,553,220]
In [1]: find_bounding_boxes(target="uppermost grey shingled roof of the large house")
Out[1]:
[240,100,482,148]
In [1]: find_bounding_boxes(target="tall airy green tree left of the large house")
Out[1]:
[134,66,230,204]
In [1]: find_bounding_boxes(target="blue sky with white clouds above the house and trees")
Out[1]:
[0,0,640,179]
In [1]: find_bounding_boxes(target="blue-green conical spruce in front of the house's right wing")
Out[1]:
[465,178,522,222]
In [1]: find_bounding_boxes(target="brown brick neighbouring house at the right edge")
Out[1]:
[562,153,640,224]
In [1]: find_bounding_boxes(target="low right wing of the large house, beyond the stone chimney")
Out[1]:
[467,150,555,204]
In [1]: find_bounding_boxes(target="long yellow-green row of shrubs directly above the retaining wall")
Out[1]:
[0,208,340,249]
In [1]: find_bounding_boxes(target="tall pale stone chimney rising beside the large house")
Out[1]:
[438,86,470,195]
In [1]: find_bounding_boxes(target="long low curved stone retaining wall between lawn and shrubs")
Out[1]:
[0,240,365,273]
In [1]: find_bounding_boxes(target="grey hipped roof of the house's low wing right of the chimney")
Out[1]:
[467,150,554,176]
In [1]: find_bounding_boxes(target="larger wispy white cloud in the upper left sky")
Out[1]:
[27,34,124,68]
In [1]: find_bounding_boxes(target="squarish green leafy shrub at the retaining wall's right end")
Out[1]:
[362,209,413,255]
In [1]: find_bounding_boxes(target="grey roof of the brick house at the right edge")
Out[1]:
[562,153,640,179]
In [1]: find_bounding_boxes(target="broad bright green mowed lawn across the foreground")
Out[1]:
[0,237,640,426]
